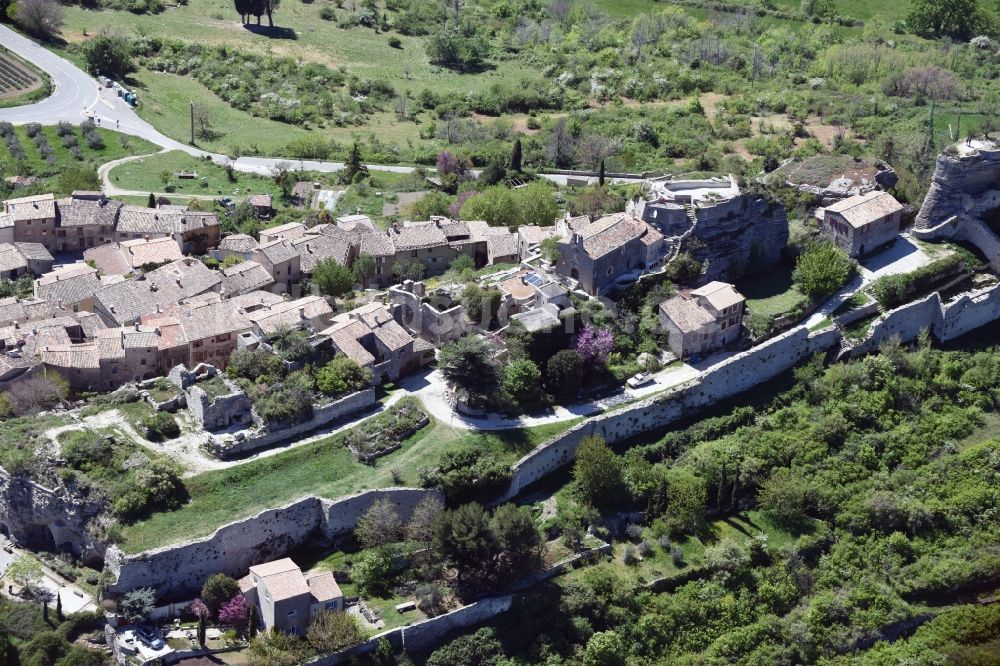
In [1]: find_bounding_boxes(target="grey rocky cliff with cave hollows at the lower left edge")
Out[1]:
[0,470,106,565]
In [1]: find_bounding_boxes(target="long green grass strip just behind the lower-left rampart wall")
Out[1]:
[121,420,578,552]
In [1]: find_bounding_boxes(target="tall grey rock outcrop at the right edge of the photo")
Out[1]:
[916,141,1000,231]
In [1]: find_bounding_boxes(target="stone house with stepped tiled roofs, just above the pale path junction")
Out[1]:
[320,303,420,385]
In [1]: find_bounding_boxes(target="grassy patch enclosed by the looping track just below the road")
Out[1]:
[108,150,281,197]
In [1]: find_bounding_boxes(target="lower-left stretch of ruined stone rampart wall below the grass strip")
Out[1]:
[105,488,440,600]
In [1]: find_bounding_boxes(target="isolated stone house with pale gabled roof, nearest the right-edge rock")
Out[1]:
[820,191,903,258]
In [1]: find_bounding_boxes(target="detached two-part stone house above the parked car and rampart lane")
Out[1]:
[660,282,746,358]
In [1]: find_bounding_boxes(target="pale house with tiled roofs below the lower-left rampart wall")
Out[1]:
[239,557,344,636]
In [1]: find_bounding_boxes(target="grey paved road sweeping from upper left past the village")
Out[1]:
[0,25,635,187]
